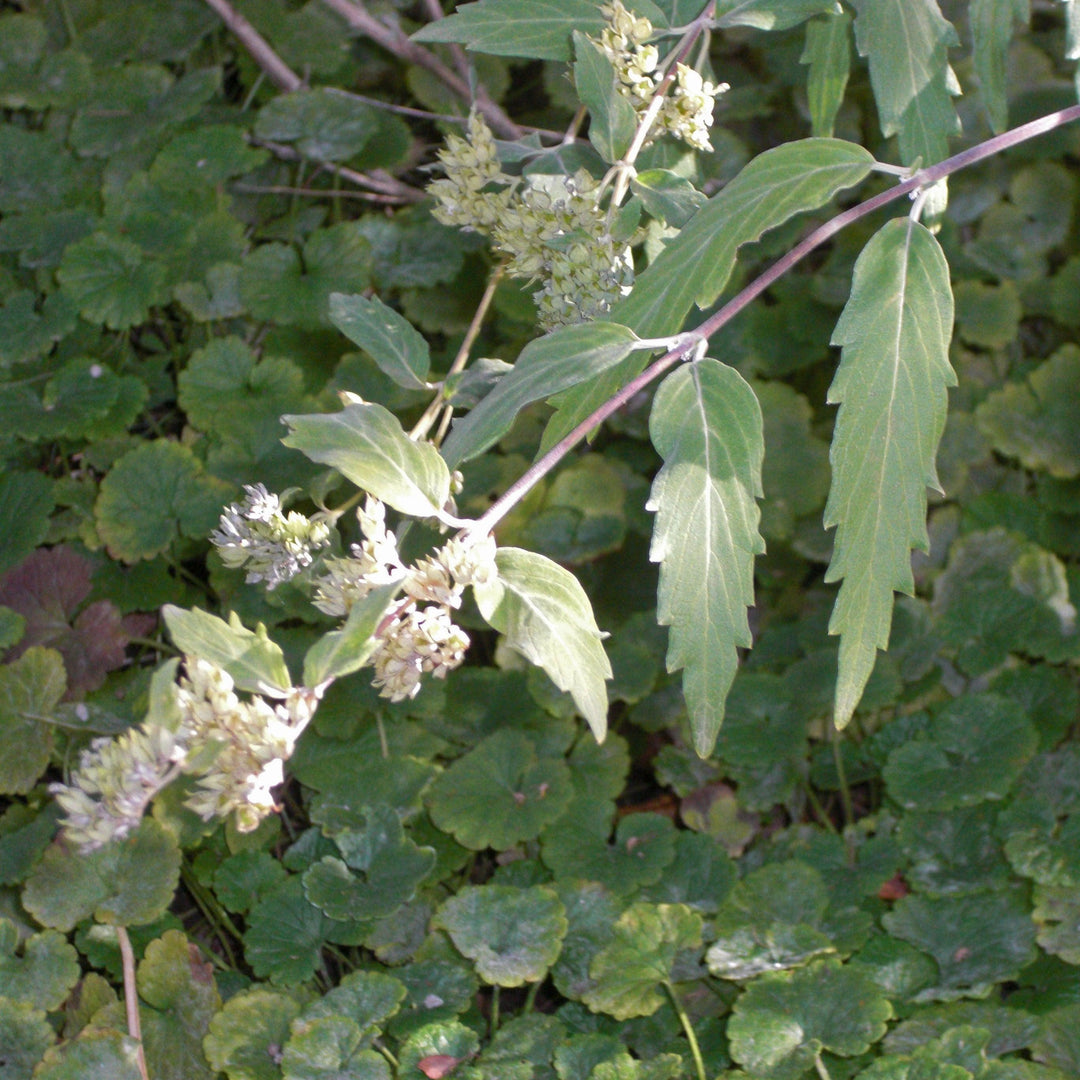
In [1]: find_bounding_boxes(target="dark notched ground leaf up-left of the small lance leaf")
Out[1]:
[240,221,372,329]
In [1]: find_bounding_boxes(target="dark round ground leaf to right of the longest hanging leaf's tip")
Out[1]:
[883,693,1039,810]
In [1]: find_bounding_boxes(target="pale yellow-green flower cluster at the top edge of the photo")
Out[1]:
[596,0,728,150]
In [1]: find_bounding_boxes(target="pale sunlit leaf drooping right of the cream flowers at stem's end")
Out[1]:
[473,548,611,740]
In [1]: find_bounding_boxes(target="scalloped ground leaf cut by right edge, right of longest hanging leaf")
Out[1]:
[975,345,1080,478]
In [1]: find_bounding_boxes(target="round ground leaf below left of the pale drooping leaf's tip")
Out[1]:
[428,729,573,851]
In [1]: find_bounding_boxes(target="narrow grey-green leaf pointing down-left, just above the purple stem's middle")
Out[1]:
[443,323,638,469]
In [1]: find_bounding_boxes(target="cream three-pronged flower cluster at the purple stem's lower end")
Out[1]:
[314,498,497,701]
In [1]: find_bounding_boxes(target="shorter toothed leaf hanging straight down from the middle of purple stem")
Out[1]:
[647,359,765,757]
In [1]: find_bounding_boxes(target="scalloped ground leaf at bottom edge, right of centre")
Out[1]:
[728,960,892,1080]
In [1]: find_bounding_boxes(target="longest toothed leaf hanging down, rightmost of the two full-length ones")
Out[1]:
[825,218,956,727]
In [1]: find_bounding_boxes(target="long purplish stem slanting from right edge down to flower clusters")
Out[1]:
[468,105,1080,536]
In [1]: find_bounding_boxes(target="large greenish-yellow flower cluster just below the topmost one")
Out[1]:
[428,112,634,328]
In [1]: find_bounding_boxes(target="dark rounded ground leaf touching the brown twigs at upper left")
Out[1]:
[255,86,379,161]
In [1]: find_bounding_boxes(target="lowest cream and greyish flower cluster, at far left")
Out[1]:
[49,657,318,851]
